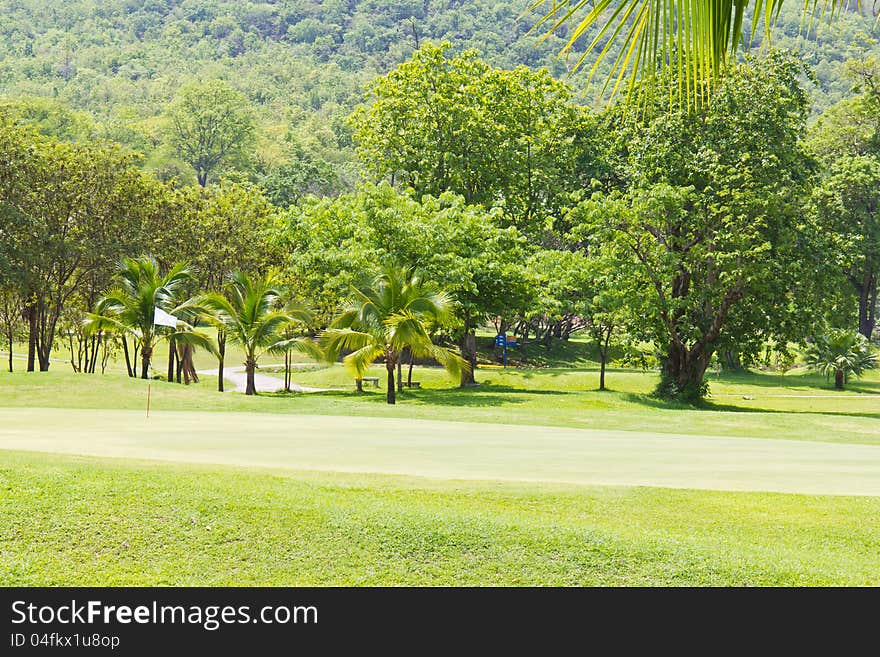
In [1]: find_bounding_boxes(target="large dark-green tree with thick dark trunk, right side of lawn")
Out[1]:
[573,54,833,400]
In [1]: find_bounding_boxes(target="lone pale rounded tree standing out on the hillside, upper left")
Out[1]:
[166,80,256,187]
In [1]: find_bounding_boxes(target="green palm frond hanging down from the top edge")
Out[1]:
[529,0,850,105]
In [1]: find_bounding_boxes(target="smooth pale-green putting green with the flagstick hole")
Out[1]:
[0,408,880,496]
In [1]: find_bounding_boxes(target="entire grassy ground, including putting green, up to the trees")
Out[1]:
[0,368,880,586]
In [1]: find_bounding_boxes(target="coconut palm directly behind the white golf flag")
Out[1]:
[86,256,214,379]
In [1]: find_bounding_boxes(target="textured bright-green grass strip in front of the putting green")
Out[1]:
[0,452,880,586]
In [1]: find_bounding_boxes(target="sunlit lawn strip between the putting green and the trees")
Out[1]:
[0,363,880,444]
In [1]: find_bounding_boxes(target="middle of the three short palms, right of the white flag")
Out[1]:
[197,272,321,395]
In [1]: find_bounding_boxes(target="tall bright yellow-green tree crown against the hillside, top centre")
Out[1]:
[352,44,586,242]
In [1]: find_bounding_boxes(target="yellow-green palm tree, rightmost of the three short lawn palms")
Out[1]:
[323,268,468,404]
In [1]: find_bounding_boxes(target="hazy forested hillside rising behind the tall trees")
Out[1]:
[0,0,877,193]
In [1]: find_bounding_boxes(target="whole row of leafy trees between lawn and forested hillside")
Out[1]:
[0,44,880,399]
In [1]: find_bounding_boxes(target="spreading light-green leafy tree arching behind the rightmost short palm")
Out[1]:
[278,184,533,386]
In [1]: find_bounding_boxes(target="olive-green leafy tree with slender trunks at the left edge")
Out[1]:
[0,120,162,371]
